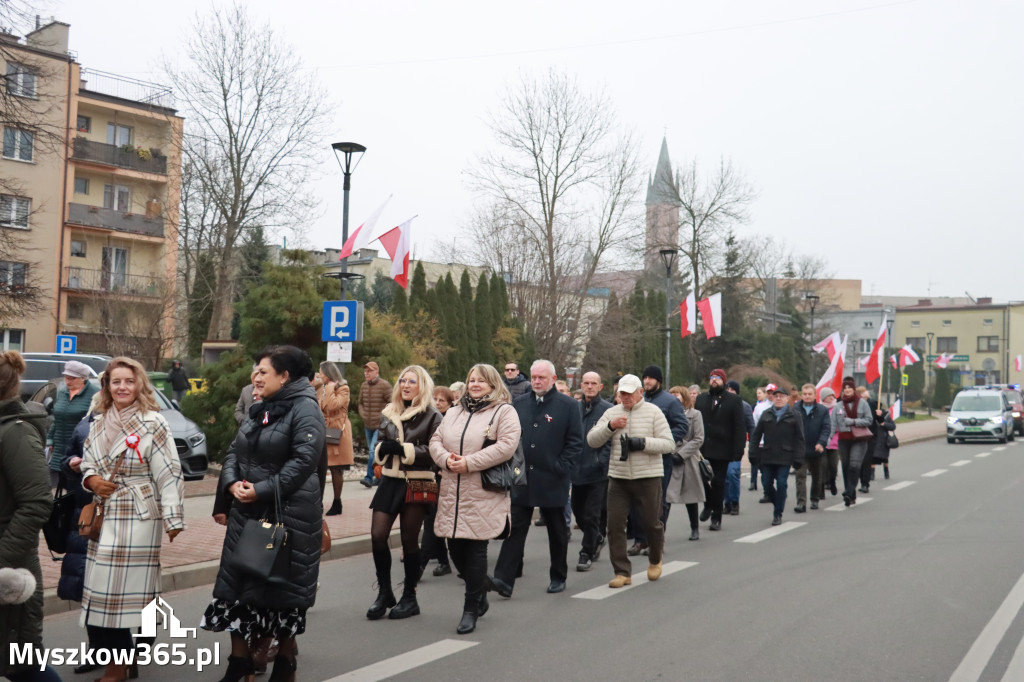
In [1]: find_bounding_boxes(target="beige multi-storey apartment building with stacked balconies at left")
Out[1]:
[0,22,182,365]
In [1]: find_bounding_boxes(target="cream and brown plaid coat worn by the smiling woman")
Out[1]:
[80,412,185,628]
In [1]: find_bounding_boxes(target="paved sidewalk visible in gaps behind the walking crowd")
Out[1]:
[39,413,946,615]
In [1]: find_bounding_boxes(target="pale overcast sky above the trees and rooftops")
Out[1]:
[51,0,1024,300]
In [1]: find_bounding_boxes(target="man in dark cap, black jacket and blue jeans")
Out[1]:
[751,387,804,525]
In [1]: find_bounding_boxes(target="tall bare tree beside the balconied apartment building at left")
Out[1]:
[167,4,328,339]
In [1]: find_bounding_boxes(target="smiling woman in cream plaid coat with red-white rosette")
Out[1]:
[81,357,185,682]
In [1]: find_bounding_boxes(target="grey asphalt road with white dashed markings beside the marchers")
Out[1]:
[36,432,1024,682]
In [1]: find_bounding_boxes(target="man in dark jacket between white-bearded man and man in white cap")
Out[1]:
[571,372,611,570]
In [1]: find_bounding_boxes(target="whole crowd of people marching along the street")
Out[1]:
[0,346,895,682]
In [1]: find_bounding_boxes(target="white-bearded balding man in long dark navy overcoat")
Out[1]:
[492,359,583,598]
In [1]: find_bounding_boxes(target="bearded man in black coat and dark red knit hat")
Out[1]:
[693,370,746,530]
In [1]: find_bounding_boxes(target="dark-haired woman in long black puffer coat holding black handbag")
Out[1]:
[200,346,326,682]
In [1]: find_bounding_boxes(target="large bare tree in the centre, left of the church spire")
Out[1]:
[469,71,639,367]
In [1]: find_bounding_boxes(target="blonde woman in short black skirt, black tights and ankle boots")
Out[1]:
[367,365,441,621]
